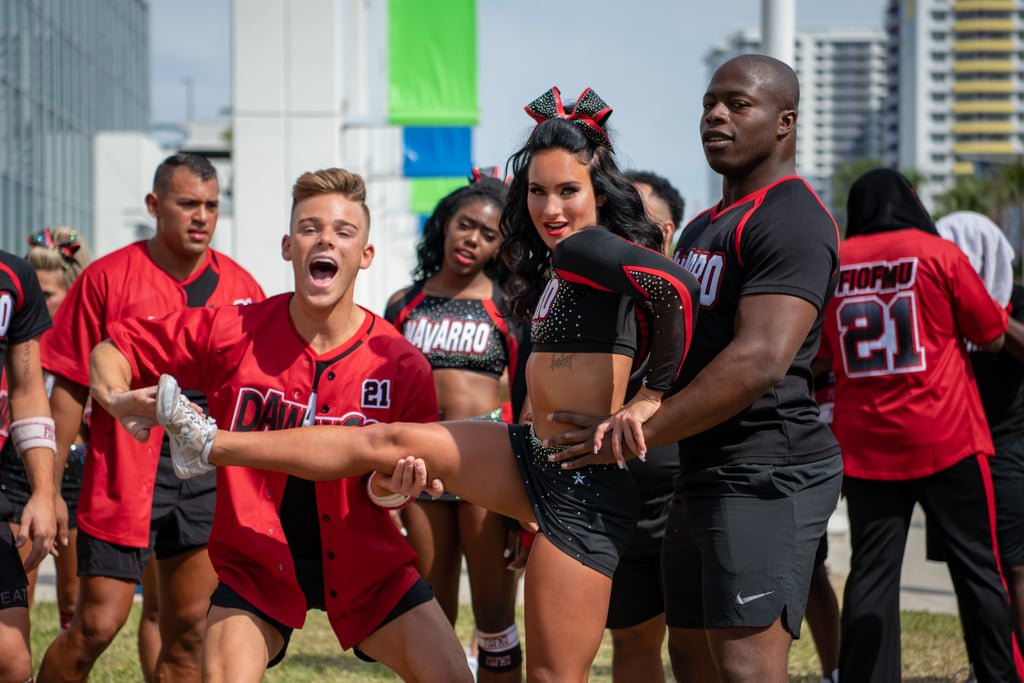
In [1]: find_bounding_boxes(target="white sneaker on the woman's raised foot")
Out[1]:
[157,375,217,479]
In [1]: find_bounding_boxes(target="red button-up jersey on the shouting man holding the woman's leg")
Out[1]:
[111,294,437,648]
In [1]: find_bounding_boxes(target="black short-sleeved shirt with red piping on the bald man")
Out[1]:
[675,176,839,472]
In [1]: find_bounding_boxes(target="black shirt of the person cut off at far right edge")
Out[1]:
[971,285,1024,444]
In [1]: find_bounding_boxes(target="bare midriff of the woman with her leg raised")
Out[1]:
[526,351,633,438]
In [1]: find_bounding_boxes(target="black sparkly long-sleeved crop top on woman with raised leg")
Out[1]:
[530,226,697,391]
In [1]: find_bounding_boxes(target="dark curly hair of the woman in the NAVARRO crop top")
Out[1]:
[413,176,509,284]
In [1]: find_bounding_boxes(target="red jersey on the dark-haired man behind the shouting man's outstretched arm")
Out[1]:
[41,242,264,548]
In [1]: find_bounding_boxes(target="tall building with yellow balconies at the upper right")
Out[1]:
[885,0,1024,210]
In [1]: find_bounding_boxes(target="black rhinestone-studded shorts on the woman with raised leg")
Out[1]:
[509,425,640,578]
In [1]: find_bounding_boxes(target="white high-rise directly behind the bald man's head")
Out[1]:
[705,27,887,204]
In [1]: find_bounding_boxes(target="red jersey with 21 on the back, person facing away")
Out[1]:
[819,228,1007,480]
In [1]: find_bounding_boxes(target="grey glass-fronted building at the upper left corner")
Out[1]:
[0,0,150,253]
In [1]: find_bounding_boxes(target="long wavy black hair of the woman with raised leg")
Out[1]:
[499,119,663,321]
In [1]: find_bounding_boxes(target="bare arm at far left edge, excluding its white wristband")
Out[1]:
[6,337,56,570]
